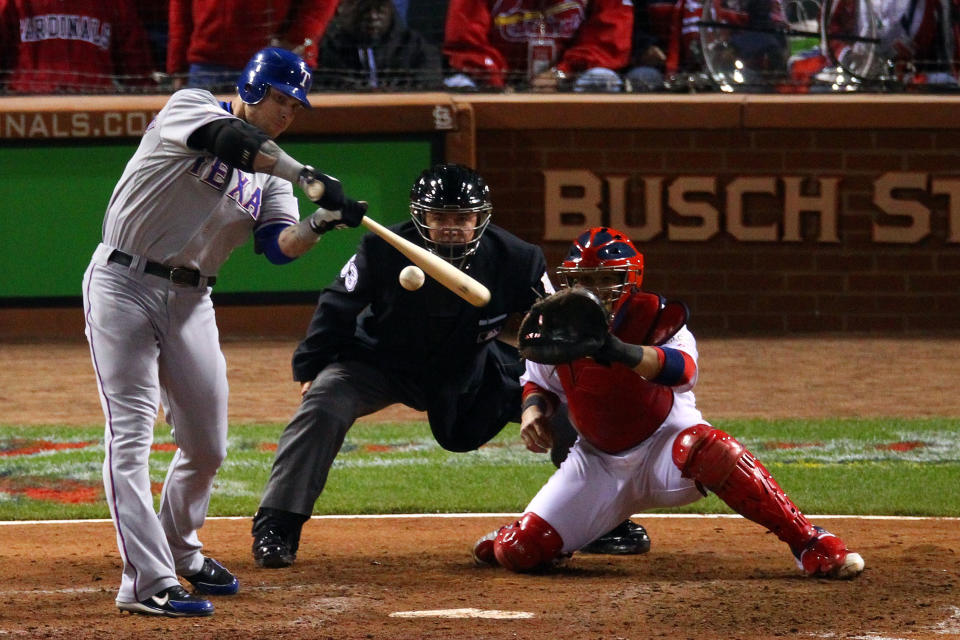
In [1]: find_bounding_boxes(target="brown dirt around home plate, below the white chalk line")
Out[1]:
[0,518,960,640]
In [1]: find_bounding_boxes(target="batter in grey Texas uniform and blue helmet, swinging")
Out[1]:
[83,48,366,617]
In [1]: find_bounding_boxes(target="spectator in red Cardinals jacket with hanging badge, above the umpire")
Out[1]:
[444,0,633,92]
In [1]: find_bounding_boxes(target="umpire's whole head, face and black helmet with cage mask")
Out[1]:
[410,164,493,267]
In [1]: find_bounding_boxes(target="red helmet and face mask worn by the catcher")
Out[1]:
[557,227,643,313]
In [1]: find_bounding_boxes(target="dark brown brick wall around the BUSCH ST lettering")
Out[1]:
[476,122,960,333]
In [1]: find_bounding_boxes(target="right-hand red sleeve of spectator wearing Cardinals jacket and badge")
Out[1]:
[557,0,633,73]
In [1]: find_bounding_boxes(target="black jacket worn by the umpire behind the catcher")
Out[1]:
[293,221,547,451]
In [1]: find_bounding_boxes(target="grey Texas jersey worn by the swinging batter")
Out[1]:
[103,89,300,276]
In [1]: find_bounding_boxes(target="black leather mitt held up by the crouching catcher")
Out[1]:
[518,287,610,364]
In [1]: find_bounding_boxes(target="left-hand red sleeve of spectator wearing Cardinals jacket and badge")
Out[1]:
[443,0,507,87]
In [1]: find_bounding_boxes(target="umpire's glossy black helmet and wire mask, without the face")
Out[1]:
[410,164,493,267]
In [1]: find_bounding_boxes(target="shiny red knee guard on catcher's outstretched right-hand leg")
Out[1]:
[673,424,744,490]
